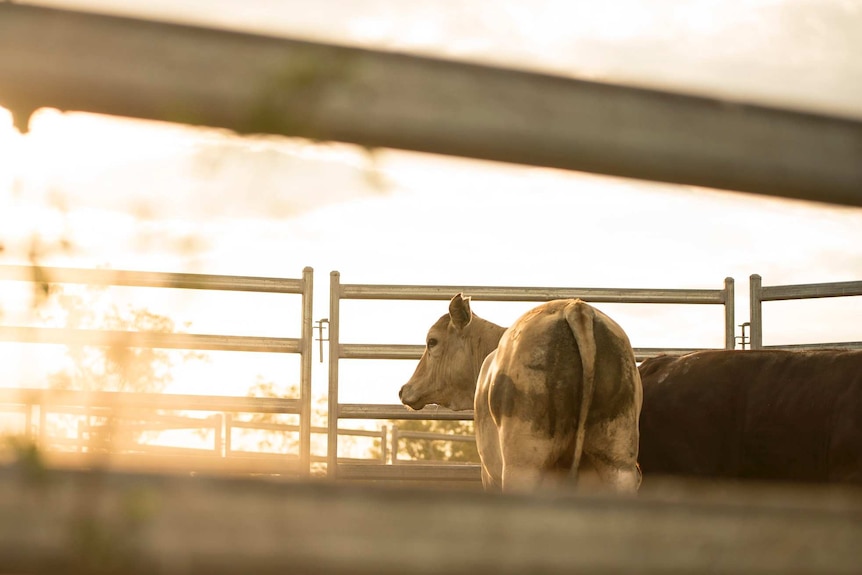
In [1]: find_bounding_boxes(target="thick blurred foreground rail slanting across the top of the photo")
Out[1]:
[0,2,862,206]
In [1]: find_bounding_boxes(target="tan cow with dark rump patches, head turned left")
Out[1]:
[399,294,642,493]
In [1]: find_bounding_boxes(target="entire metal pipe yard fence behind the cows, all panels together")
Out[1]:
[0,266,862,482]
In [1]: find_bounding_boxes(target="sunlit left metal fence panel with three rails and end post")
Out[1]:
[0,266,314,474]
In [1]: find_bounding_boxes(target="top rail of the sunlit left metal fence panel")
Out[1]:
[0,266,303,294]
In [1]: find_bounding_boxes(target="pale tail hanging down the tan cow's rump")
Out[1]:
[565,300,596,483]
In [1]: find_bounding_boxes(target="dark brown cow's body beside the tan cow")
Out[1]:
[639,350,862,484]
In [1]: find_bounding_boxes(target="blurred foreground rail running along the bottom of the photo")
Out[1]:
[0,467,862,575]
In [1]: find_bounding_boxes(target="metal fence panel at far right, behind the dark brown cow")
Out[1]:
[748,274,862,350]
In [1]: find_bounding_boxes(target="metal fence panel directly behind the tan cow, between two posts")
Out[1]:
[327,271,735,480]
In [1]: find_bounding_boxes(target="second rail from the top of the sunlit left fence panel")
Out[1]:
[0,326,302,353]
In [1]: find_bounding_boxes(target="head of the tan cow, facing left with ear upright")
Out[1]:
[398,294,504,410]
